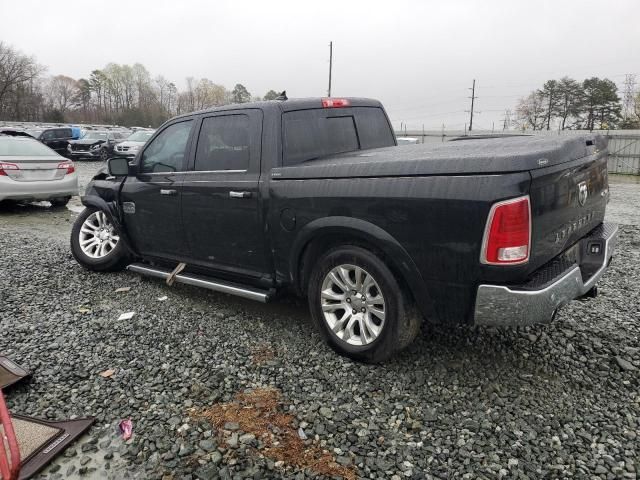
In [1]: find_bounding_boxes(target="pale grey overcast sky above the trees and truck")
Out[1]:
[0,0,640,129]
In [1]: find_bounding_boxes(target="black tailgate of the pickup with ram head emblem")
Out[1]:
[530,137,609,268]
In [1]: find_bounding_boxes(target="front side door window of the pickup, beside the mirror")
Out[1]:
[141,120,193,173]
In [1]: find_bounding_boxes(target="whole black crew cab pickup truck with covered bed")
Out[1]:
[71,98,617,362]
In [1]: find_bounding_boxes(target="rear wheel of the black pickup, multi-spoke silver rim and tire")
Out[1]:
[308,245,421,363]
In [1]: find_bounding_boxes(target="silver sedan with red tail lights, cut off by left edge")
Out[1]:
[0,135,78,206]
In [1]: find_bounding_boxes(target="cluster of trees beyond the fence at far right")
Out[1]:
[516,77,640,130]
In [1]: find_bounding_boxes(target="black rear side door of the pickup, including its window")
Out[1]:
[182,109,268,277]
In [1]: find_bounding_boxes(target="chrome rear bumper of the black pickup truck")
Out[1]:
[474,223,618,326]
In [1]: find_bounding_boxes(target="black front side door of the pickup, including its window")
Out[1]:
[120,119,195,260]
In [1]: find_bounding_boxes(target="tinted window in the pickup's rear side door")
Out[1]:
[195,115,249,172]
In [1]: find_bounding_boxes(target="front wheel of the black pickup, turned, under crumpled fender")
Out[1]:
[71,208,129,272]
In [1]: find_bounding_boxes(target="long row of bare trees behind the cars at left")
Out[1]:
[0,42,278,126]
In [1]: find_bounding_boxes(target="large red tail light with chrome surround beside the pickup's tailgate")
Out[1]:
[480,195,531,265]
